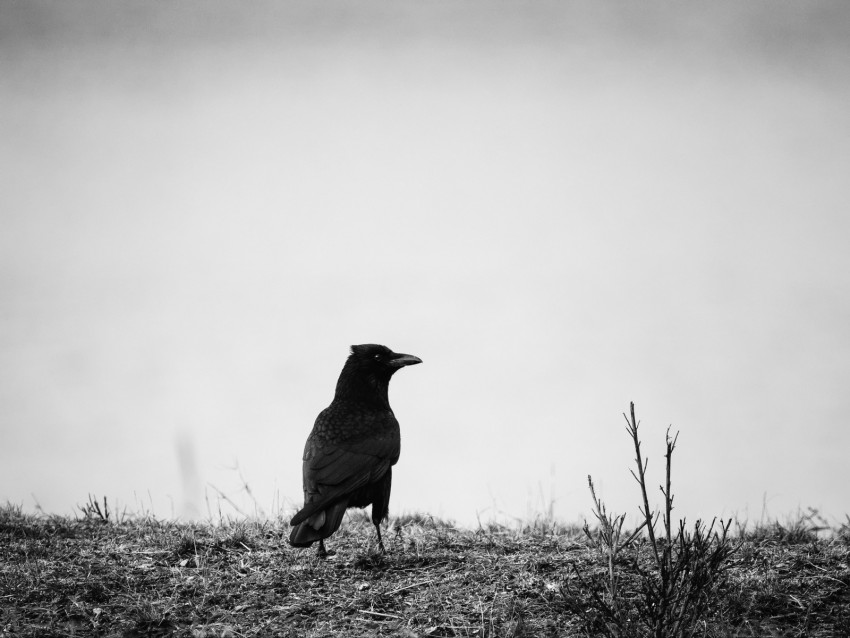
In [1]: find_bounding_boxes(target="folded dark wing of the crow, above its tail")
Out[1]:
[291,435,400,525]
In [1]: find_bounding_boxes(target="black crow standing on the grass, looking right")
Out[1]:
[289,343,422,556]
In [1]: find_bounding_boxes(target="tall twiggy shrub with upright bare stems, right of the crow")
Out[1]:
[562,403,736,638]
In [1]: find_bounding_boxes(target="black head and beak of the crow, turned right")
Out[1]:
[337,343,422,402]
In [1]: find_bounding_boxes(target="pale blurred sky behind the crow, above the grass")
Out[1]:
[0,0,850,526]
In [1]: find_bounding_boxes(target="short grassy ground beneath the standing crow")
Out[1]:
[0,506,850,638]
